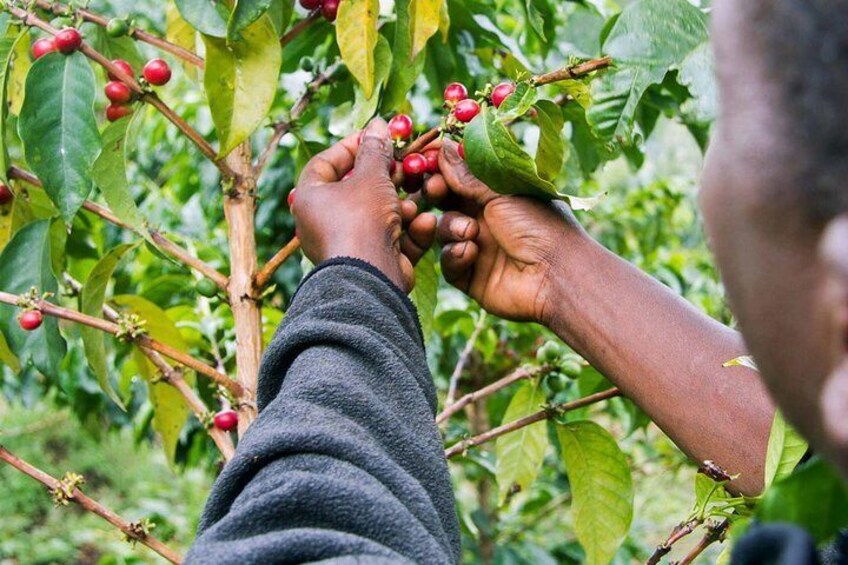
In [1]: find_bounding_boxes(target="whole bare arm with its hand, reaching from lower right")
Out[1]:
[424,141,774,495]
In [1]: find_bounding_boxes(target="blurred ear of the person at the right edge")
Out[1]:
[819,213,848,447]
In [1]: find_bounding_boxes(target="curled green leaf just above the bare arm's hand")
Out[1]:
[465,107,558,199]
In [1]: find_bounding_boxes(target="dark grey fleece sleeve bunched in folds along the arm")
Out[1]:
[186,259,459,564]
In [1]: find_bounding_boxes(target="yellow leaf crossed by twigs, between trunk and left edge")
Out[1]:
[112,296,194,461]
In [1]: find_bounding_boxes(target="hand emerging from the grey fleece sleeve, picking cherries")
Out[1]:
[292,119,436,292]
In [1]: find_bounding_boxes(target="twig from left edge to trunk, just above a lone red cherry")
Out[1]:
[0,292,243,397]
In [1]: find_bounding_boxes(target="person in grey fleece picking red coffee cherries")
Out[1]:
[187,0,848,564]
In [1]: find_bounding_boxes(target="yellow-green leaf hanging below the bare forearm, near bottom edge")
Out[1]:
[557,421,633,565]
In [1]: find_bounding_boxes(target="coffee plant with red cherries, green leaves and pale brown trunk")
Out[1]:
[0,0,836,563]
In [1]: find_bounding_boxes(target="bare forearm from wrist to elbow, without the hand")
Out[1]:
[547,235,774,494]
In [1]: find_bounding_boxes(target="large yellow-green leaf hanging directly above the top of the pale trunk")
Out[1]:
[203,16,282,157]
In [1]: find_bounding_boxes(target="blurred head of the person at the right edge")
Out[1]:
[701,0,848,473]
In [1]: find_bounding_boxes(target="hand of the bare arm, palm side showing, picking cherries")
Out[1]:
[424,141,585,325]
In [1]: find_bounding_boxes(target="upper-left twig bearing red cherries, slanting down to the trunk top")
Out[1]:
[5,4,235,178]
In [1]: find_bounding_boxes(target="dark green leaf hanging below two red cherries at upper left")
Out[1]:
[18,53,100,222]
